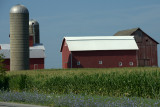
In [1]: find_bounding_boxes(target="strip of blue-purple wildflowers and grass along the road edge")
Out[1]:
[0,91,160,107]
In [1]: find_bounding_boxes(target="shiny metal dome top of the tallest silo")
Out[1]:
[10,4,29,14]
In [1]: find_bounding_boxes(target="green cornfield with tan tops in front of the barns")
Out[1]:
[0,68,160,98]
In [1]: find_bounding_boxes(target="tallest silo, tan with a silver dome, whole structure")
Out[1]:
[10,4,29,71]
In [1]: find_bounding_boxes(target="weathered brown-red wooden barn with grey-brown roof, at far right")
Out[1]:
[114,28,159,67]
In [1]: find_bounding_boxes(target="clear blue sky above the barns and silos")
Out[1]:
[0,0,160,68]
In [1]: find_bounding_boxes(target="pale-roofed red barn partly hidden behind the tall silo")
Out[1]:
[0,44,45,71]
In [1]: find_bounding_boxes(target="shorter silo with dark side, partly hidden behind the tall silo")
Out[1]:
[29,19,40,44]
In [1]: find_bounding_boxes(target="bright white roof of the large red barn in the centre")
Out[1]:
[64,36,138,51]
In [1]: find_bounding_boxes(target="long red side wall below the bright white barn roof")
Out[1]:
[72,51,137,68]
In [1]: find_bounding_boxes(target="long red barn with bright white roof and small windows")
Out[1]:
[60,36,138,68]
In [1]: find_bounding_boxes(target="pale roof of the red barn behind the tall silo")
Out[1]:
[0,44,45,59]
